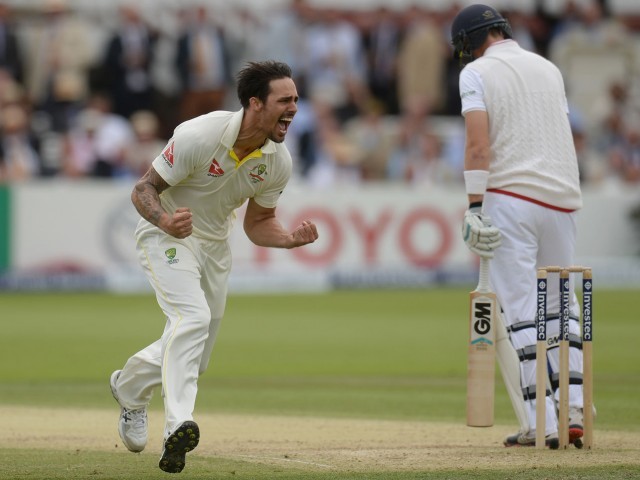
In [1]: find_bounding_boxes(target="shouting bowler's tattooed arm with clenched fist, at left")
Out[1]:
[131,167,193,238]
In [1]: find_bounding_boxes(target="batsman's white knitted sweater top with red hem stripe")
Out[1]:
[460,40,582,210]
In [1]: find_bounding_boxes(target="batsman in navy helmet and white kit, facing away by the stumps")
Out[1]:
[451,4,583,448]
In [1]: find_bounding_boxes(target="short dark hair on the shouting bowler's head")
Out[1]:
[236,60,291,108]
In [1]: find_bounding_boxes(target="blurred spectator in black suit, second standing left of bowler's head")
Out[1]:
[103,5,157,118]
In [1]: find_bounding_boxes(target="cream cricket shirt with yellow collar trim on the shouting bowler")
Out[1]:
[138,110,292,240]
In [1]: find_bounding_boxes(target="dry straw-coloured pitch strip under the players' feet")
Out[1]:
[0,406,640,472]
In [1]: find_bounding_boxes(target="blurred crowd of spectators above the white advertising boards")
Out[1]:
[0,0,640,186]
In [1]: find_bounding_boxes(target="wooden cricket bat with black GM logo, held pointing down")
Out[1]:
[467,258,498,427]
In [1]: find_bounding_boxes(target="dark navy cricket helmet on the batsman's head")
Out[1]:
[451,4,513,65]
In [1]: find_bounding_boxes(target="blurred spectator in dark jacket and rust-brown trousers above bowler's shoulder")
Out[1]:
[175,6,231,122]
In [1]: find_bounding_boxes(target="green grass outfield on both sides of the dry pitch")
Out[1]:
[0,289,640,480]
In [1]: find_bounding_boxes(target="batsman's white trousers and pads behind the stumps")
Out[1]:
[483,192,582,435]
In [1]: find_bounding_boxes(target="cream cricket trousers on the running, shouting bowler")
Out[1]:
[118,226,231,438]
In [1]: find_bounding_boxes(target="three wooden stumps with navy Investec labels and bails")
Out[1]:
[536,266,593,449]
